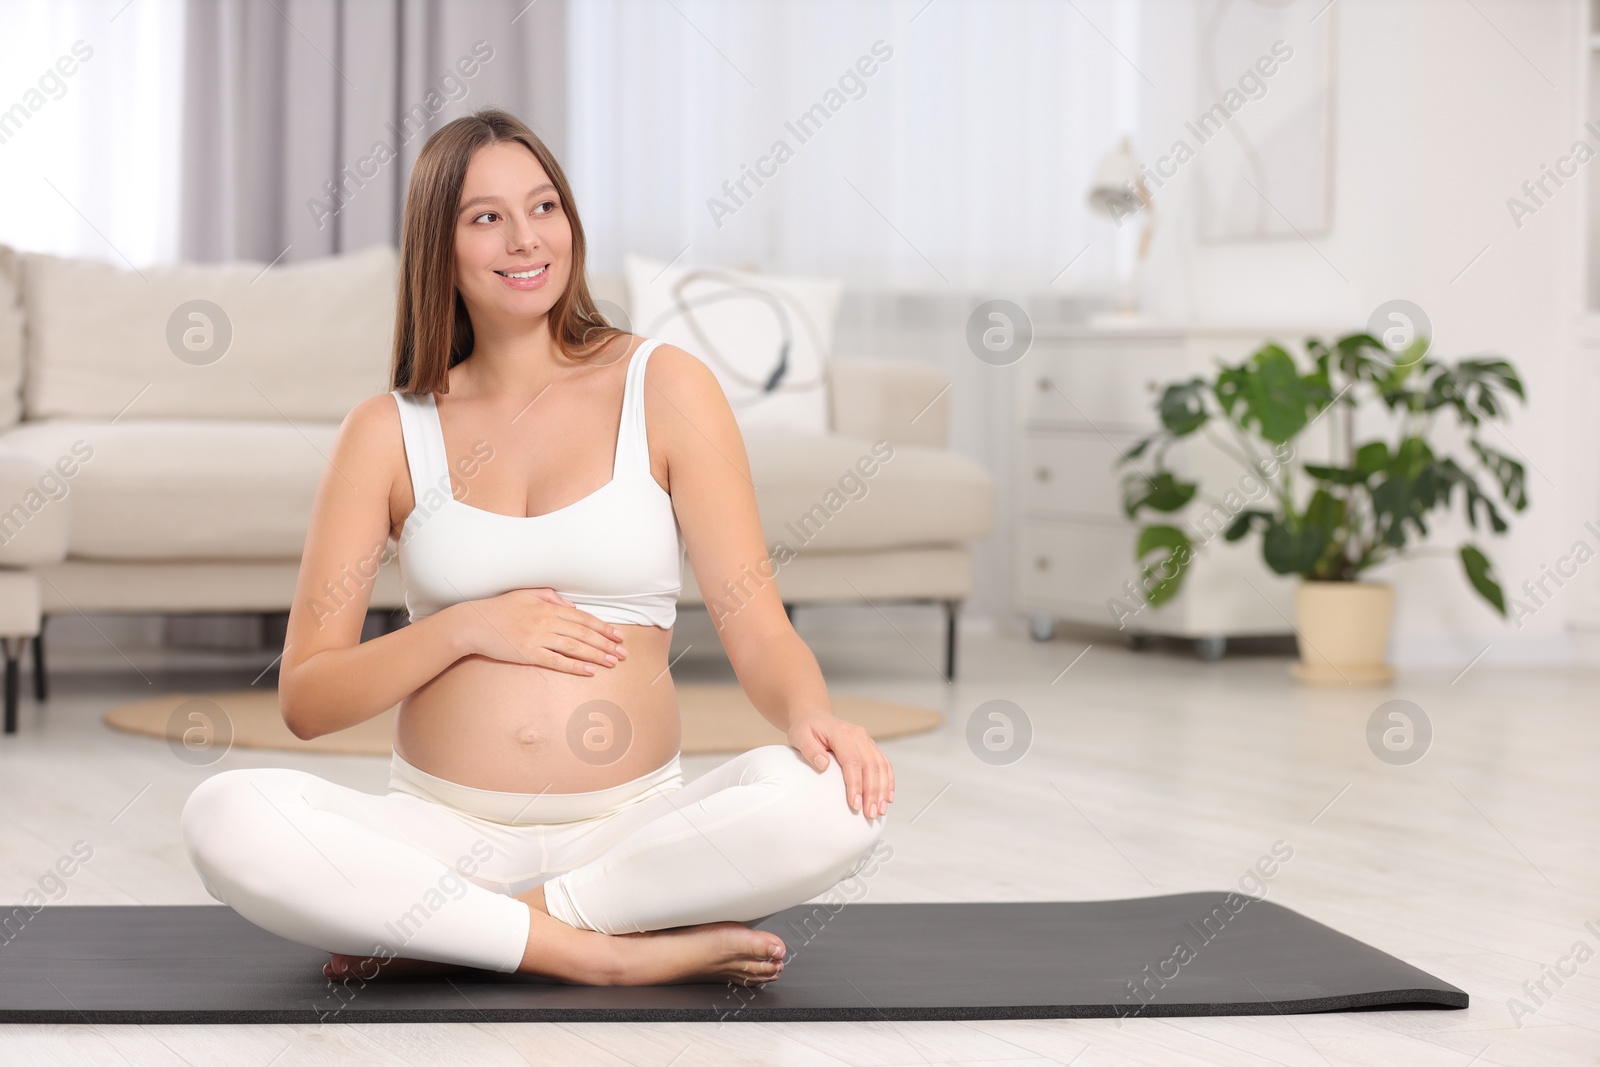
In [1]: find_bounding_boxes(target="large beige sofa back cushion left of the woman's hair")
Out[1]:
[21,245,398,422]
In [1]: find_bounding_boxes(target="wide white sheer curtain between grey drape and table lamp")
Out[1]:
[563,0,1144,295]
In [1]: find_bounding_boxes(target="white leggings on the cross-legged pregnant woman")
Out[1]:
[182,745,888,973]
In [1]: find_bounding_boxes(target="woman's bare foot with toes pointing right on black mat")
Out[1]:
[588,923,787,985]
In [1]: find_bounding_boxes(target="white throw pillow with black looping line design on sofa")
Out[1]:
[622,254,843,434]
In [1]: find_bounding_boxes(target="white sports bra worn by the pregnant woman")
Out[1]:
[392,339,683,629]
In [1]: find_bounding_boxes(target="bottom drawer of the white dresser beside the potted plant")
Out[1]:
[1014,520,1142,625]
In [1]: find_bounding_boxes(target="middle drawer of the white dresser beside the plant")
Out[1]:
[1018,430,1141,522]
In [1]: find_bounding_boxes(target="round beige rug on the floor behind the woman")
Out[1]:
[106,683,944,757]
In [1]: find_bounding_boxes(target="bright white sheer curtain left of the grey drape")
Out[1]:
[0,0,184,267]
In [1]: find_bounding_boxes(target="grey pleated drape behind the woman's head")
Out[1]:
[176,0,566,262]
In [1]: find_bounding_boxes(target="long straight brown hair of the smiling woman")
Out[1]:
[389,107,626,395]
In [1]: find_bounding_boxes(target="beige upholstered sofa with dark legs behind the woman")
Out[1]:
[0,245,994,733]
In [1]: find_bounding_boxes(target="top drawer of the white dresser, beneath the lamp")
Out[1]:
[1021,342,1189,430]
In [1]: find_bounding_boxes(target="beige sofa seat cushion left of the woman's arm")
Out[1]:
[0,414,342,560]
